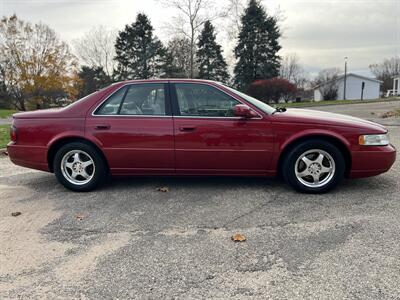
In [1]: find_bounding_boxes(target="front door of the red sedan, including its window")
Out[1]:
[171,83,273,175]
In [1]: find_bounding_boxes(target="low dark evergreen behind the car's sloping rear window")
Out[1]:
[78,66,112,98]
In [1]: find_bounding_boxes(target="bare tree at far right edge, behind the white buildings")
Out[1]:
[369,56,400,91]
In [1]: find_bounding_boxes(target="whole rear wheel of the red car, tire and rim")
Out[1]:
[53,142,106,192]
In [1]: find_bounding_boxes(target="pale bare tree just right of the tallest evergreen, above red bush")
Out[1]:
[279,53,307,89]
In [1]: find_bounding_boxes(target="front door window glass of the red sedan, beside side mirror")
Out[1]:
[175,83,240,117]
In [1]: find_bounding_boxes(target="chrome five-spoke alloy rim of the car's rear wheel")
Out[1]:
[61,150,96,185]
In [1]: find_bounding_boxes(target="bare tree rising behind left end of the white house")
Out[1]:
[314,68,341,100]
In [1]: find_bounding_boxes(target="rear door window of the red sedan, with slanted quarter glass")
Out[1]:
[96,83,165,115]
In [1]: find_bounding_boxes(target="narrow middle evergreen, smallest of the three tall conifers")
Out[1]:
[196,21,229,82]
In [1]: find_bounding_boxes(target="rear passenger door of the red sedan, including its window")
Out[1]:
[86,82,174,174]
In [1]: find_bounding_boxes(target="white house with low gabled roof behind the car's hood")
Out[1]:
[314,73,382,101]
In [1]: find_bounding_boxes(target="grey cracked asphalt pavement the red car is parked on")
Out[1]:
[0,105,400,299]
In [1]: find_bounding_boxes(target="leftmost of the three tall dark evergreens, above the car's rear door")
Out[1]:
[115,14,165,80]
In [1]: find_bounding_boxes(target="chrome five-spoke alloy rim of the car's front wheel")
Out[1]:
[295,149,335,188]
